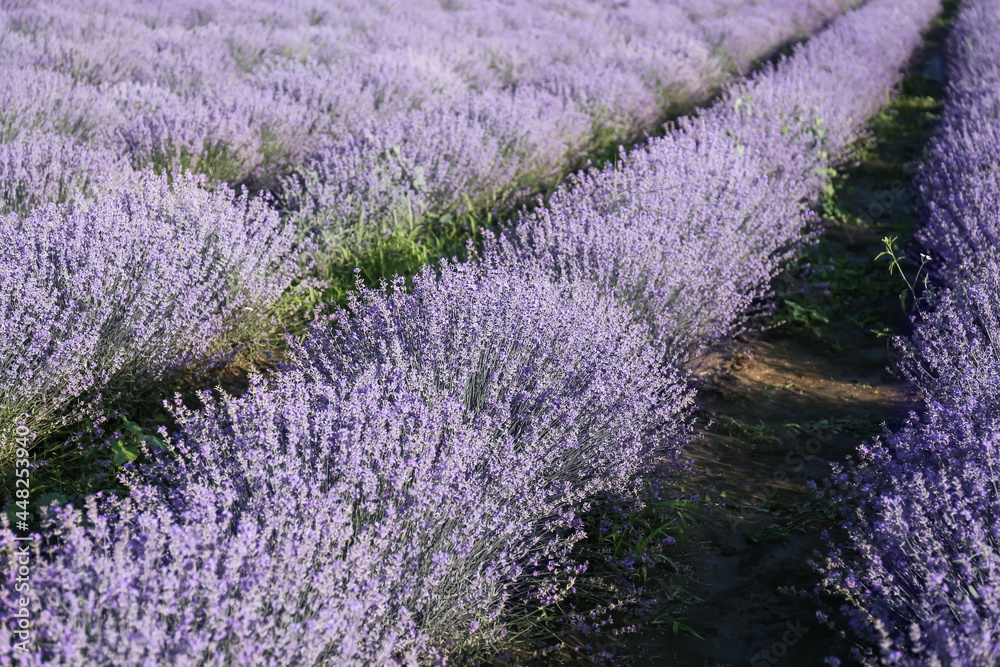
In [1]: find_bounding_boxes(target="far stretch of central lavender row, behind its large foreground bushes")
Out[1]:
[489,0,938,363]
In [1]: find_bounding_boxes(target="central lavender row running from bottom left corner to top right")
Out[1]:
[0,0,936,665]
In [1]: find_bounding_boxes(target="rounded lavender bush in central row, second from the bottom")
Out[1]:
[296,263,686,492]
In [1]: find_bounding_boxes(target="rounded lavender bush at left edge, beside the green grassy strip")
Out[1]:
[0,176,295,452]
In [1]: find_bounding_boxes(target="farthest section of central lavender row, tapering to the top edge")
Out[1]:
[707,0,940,201]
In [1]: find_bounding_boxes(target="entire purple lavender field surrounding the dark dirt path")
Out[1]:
[0,0,1000,666]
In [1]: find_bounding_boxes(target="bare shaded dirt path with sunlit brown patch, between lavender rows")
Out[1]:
[615,316,919,667]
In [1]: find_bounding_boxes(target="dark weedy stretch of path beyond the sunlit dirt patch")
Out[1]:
[765,54,943,336]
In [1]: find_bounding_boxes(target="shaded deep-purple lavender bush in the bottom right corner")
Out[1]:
[824,402,1000,666]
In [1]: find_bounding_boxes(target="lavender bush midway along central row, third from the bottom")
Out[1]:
[487,121,804,362]
